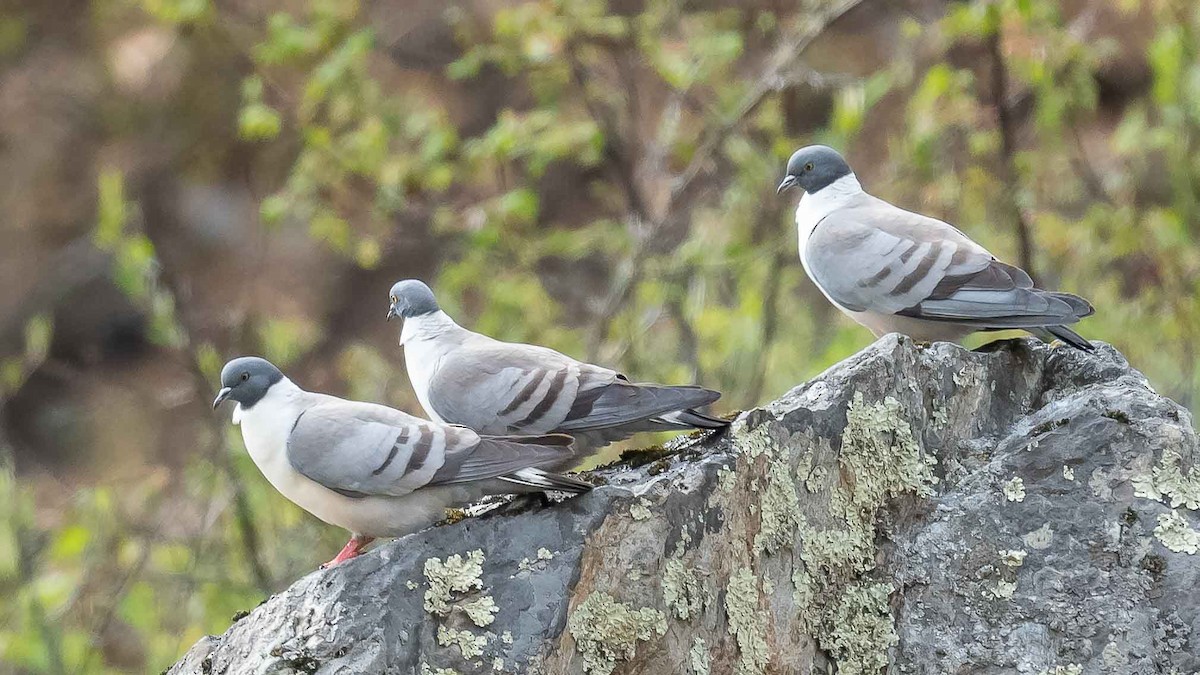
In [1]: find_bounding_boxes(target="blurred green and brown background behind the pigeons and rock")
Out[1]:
[0,0,1200,673]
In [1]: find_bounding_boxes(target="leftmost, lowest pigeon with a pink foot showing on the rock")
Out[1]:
[212,357,592,568]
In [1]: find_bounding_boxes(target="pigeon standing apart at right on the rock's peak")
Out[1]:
[778,145,1094,351]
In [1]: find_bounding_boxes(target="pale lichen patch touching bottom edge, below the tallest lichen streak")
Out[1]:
[821,583,900,675]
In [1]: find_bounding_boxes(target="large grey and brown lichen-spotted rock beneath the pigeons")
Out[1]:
[170,336,1200,675]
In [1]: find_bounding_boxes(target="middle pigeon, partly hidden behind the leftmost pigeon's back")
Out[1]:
[388,279,730,456]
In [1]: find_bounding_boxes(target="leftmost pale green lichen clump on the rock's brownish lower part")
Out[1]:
[566,592,667,675]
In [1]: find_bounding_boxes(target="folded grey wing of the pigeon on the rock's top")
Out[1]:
[808,199,1092,328]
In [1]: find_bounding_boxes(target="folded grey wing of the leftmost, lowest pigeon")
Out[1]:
[287,401,480,496]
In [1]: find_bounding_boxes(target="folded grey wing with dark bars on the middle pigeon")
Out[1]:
[428,344,604,435]
